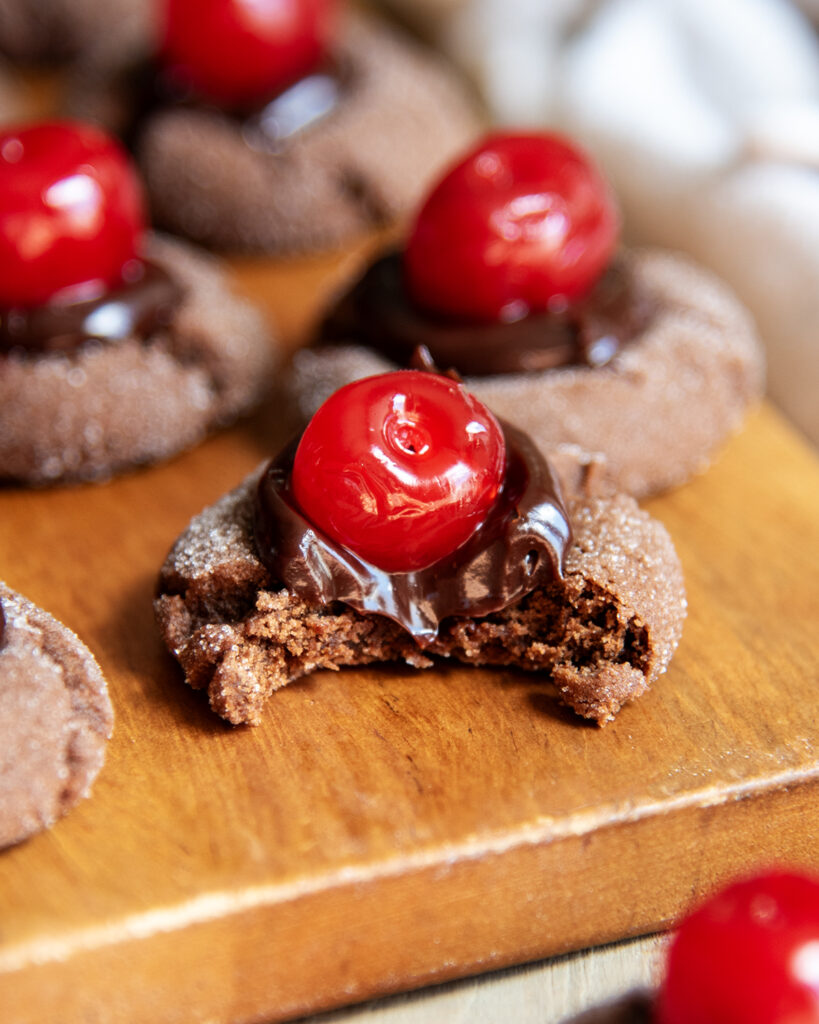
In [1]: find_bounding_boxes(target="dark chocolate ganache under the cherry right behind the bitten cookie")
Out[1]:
[316,252,654,377]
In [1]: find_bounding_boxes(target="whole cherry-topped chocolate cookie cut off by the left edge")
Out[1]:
[0,122,276,483]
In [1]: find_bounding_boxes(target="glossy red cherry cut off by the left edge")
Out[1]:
[0,122,144,308]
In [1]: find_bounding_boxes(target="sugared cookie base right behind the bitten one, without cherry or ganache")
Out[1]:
[290,250,764,498]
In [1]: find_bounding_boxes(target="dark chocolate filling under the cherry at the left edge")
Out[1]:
[0,260,183,352]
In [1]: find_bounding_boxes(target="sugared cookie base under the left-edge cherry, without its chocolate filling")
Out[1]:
[0,237,276,484]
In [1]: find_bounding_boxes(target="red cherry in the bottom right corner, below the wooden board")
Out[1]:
[655,871,819,1024]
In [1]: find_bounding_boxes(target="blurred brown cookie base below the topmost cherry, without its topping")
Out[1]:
[137,15,479,253]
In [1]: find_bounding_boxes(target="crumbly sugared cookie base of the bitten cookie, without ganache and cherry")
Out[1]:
[155,473,686,725]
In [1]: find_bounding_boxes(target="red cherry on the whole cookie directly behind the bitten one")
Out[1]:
[404,134,619,321]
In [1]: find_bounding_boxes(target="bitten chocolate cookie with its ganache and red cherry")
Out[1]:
[155,371,686,724]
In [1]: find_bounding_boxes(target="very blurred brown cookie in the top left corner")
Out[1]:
[0,0,154,62]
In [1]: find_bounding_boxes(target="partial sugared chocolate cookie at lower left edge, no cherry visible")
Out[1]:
[0,583,114,848]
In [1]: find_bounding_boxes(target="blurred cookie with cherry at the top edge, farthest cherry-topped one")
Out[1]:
[72,0,480,254]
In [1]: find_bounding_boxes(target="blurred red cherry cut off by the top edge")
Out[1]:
[161,0,338,106]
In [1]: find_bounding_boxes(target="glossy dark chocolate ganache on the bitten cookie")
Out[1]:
[255,423,571,645]
